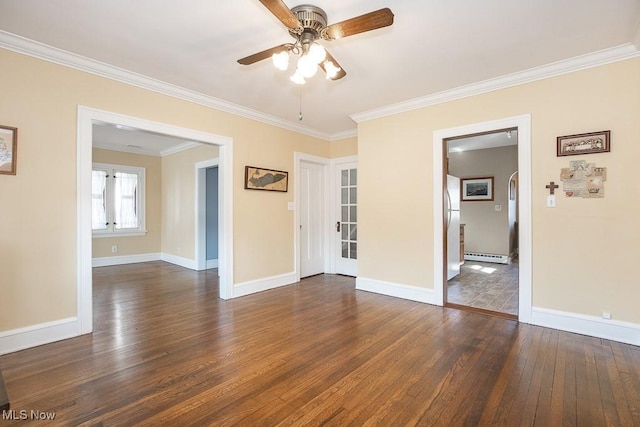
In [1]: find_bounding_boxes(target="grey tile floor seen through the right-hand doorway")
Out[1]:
[447,260,518,315]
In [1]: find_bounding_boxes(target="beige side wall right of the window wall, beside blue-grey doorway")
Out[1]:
[162,144,219,260]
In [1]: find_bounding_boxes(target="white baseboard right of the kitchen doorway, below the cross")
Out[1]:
[531,307,640,346]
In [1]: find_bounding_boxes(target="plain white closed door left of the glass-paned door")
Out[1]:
[300,161,324,277]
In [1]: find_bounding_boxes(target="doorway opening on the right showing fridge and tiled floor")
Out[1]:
[443,128,519,319]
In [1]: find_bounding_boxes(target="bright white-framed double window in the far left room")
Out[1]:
[91,163,146,237]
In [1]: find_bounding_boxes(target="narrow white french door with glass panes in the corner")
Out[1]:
[335,162,358,276]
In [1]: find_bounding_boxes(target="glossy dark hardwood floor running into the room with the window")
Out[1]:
[0,262,640,426]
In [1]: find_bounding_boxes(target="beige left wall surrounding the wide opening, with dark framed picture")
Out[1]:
[0,50,330,332]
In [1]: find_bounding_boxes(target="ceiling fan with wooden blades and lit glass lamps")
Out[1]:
[238,0,393,84]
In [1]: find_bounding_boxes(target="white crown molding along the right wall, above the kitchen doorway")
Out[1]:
[350,43,640,123]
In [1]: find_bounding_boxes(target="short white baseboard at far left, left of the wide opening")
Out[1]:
[0,317,80,354]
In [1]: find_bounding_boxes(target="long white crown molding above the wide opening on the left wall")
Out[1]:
[0,30,344,141]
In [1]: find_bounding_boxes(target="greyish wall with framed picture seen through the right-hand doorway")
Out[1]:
[449,146,518,255]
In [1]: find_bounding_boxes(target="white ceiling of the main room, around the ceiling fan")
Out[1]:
[0,0,640,139]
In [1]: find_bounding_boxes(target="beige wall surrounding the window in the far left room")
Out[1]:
[91,148,161,258]
